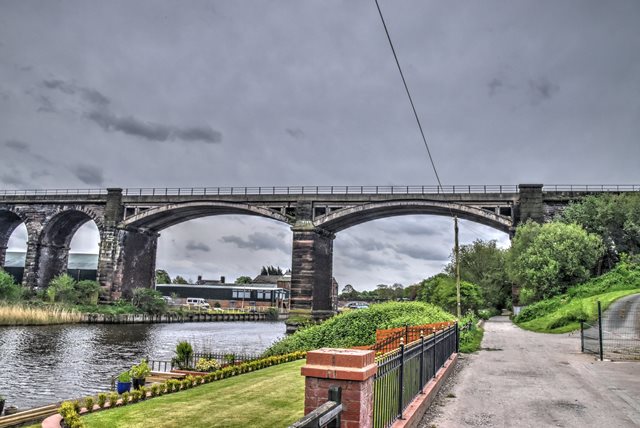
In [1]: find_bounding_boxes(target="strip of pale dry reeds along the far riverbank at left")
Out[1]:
[0,305,82,325]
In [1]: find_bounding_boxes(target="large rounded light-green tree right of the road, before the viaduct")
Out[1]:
[507,221,604,304]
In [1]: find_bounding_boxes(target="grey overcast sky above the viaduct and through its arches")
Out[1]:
[0,0,640,289]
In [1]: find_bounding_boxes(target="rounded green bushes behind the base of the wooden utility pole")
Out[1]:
[418,273,483,314]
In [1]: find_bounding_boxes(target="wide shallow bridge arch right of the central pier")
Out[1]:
[313,200,513,233]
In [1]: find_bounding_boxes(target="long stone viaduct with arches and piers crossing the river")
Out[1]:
[0,184,640,318]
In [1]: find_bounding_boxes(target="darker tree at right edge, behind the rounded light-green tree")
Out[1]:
[559,193,640,270]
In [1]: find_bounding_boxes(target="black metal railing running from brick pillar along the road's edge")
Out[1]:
[373,324,459,428]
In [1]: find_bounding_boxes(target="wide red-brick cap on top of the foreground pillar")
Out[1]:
[301,348,378,382]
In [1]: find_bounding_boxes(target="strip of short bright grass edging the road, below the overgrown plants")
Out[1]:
[517,288,640,333]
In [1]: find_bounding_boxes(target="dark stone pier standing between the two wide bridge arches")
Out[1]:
[291,223,337,319]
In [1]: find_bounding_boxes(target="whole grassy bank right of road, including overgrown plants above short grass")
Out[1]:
[514,262,640,333]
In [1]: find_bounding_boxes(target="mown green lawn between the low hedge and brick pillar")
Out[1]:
[82,360,305,428]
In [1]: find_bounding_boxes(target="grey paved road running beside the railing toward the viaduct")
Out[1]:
[421,317,640,428]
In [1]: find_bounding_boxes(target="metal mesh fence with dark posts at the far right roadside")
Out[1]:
[580,294,640,360]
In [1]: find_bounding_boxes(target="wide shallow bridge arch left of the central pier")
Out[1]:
[120,202,290,232]
